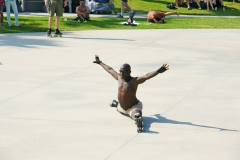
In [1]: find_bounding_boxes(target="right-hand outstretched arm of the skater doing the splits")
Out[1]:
[137,64,169,84]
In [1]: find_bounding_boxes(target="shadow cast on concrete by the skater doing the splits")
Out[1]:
[122,114,238,134]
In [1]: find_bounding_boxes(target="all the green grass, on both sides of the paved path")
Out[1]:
[0,0,240,34]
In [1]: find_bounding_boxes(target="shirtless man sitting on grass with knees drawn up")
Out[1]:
[75,0,91,21]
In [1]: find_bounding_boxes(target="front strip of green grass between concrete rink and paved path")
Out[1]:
[0,16,240,33]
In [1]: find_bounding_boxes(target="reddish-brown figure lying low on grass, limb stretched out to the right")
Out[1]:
[147,11,179,23]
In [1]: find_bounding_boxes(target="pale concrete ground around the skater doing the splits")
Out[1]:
[0,29,240,160]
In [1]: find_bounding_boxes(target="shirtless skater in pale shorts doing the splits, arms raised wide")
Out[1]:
[93,55,169,132]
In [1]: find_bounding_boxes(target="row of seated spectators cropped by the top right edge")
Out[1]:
[174,0,225,11]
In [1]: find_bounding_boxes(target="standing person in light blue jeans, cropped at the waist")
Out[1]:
[5,0,21,28]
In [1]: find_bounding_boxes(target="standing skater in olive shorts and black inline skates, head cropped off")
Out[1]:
[45,0,68,36]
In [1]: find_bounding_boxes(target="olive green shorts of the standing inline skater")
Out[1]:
[48,0,64,16]
